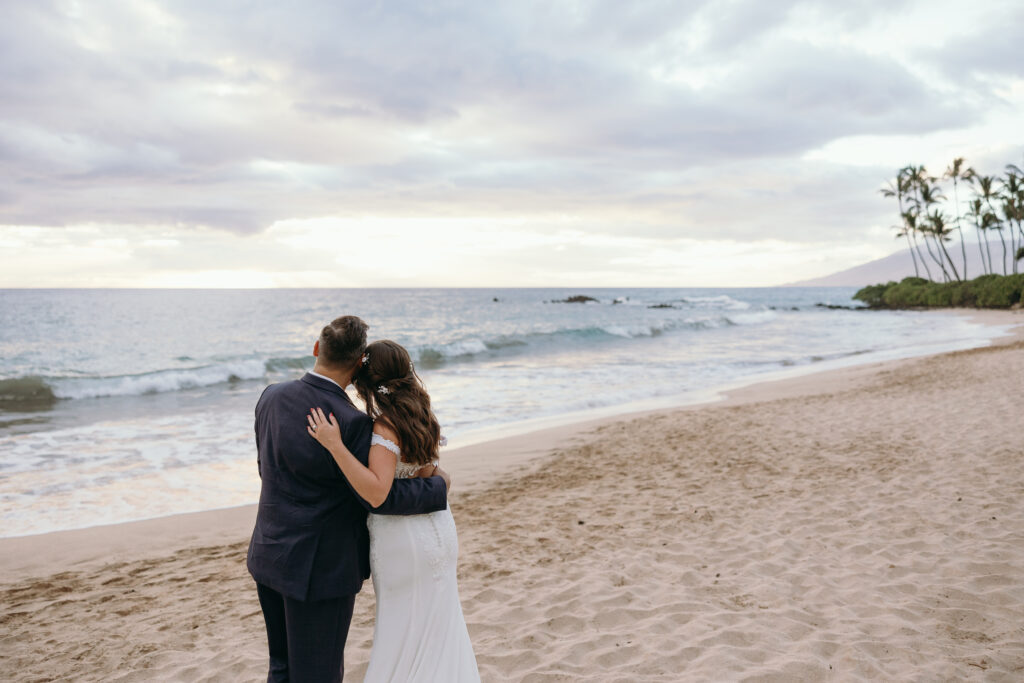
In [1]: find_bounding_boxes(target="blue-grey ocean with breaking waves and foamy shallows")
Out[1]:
[0,288,1000,537]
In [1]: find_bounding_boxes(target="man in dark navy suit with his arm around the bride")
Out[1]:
[246,315,449,683]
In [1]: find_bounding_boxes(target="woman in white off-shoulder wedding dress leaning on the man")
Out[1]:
[307,340,480,683]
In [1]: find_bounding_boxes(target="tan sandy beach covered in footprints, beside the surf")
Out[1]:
[0,311,1024,681]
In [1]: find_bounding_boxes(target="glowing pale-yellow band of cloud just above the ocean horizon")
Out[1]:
[0,217,882,288]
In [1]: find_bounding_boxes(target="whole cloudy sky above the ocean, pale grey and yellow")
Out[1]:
[0,0,1024,288]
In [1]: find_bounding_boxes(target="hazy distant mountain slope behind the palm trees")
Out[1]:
[782,242,1002,287]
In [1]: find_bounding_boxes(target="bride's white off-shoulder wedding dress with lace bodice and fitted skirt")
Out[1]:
[364,434,480,683]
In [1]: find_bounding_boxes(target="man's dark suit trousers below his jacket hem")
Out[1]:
[256,583,355,683]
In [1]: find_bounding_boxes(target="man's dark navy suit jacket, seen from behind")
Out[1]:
[246,374,447,600]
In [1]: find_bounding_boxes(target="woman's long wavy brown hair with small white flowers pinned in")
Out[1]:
[352,339,441,465]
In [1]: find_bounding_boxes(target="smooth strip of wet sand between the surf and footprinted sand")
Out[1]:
[0,308,1024,584]
